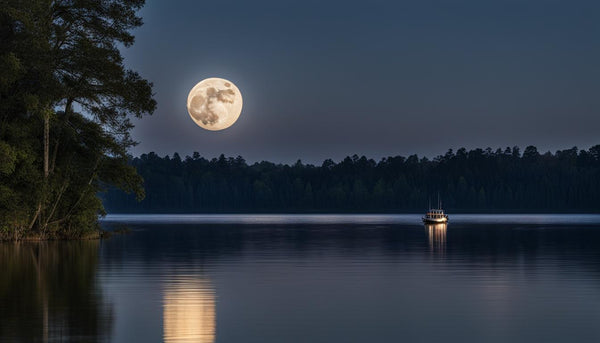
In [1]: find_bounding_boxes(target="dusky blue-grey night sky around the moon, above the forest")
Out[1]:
[123,0,600,163]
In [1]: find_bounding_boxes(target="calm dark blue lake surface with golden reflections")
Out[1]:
[0,215,600,343]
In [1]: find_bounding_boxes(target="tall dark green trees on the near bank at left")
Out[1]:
[0,0,156,237]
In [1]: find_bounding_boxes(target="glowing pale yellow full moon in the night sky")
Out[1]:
[187,77,242,131]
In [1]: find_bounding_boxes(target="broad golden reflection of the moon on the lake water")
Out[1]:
[163,278,216,343]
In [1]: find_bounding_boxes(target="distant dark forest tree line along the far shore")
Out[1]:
[103,145,600,213]
